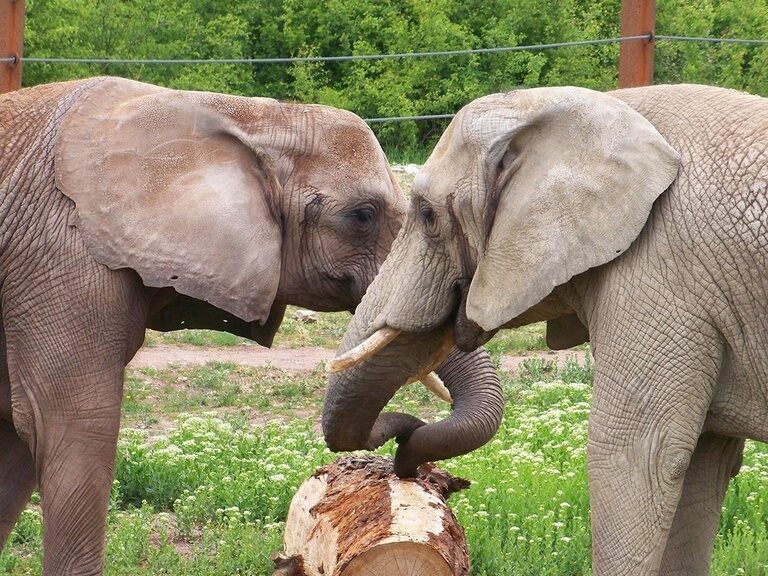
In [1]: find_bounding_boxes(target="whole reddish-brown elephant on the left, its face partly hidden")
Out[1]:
[0,78,405,576]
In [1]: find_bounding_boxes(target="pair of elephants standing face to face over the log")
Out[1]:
[0,78,768,575]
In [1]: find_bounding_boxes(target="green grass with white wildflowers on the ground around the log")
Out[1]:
[6,359,768,576]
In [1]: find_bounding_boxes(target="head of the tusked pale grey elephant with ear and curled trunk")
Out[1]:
[323,83,678,474]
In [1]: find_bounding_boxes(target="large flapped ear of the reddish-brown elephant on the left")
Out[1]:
[56,78,282,322]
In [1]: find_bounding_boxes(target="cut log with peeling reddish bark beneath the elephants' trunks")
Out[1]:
[273,456,469,576]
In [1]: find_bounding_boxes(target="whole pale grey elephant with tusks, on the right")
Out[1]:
[323,84,768,575]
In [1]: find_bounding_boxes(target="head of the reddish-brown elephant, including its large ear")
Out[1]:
[56,78,405,345]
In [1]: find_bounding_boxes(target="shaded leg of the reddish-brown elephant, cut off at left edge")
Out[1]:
[0,319,35,550]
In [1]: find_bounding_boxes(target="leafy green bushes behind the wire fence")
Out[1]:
[24,0,768,161]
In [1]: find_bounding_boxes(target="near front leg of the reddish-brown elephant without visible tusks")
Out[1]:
[3,264,147,576]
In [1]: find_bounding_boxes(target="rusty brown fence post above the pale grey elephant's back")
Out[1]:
[619,0,656,88]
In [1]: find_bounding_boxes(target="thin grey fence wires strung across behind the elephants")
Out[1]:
[7,34,768,124]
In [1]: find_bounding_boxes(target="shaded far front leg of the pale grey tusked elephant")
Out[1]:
[660,433,744,576]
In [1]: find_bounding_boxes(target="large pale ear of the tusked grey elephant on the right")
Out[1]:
[467,88,679,331]
